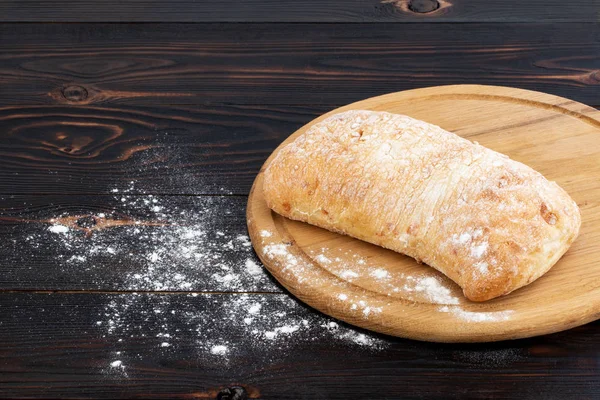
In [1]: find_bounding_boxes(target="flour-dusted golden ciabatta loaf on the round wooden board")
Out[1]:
[263,110,581,301]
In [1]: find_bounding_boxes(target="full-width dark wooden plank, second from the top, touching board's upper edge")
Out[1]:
[0,23,600,106]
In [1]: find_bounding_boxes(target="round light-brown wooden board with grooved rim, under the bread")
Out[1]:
[247,85,600,342]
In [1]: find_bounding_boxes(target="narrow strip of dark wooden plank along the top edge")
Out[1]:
[0,0,598,22]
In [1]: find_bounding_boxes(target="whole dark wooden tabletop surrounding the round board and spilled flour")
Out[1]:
[0,0,600,399]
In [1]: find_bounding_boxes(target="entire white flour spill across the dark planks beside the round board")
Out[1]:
[12,183,388,377]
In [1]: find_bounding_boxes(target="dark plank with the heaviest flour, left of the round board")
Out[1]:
[0,195,281,292]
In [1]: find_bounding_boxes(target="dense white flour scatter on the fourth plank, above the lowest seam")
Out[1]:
[25,183,280,292]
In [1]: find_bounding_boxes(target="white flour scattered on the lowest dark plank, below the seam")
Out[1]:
[93,293,391,373]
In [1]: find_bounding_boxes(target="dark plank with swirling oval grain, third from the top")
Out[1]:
[0,106,327,195]
